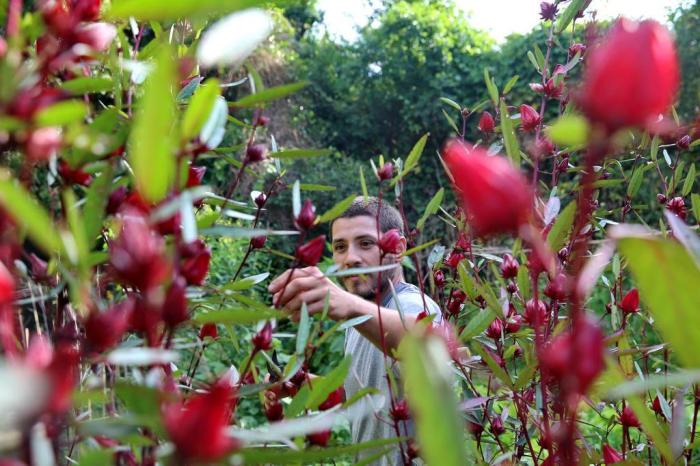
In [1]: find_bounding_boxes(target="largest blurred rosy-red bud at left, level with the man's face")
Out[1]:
[109,215,170,291]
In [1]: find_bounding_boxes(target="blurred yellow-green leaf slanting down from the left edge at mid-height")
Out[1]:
[0,170,64,254]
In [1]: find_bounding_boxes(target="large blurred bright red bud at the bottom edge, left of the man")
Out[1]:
[163,383,240,464]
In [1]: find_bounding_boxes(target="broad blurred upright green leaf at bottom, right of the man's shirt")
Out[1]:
[399,334,470,466]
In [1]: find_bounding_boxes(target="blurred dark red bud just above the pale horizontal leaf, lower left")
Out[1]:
[85,298,134,353]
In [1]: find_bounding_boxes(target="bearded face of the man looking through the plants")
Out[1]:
[331,215,399,299]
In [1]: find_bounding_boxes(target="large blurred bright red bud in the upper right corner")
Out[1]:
[578,18,679,131]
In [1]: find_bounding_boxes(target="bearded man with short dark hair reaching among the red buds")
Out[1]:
[269,197,440,465]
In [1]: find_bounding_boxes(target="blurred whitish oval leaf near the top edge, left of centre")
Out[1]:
[197,8,273,67]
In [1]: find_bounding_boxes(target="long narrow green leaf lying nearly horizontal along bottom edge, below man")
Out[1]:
[236,438,400,464]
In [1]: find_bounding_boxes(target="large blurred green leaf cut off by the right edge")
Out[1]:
[619,238,700,368]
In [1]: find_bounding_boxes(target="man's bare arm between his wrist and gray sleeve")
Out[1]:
[352,298,414,356]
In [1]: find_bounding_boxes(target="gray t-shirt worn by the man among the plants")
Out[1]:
[344,282,441,466]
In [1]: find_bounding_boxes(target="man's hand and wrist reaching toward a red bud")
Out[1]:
[267,267,364,321]
